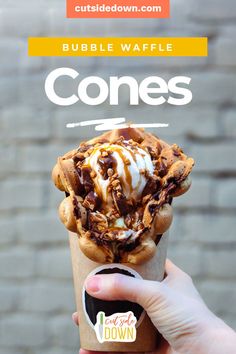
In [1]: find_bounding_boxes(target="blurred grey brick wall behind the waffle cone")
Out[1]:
[0,0,236,354]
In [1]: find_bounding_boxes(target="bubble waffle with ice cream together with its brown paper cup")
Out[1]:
[52,128,194,352]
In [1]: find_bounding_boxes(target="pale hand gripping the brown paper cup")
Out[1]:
[73,260,236,354]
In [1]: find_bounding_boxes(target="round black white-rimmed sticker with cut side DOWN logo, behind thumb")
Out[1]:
[82,263,145,343]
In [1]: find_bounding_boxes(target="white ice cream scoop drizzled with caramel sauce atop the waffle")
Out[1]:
[84,141,154,203]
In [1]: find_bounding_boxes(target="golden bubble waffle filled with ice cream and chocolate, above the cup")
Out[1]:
[52,127,194,264]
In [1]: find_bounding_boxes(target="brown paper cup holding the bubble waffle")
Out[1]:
[69,232,168,352]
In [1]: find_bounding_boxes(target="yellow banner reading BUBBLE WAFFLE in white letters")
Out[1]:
[28,37,208,57]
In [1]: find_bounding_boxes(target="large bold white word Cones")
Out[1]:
[45,68,193,106]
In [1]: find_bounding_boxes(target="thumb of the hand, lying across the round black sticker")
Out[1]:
[85,273,166,309]
